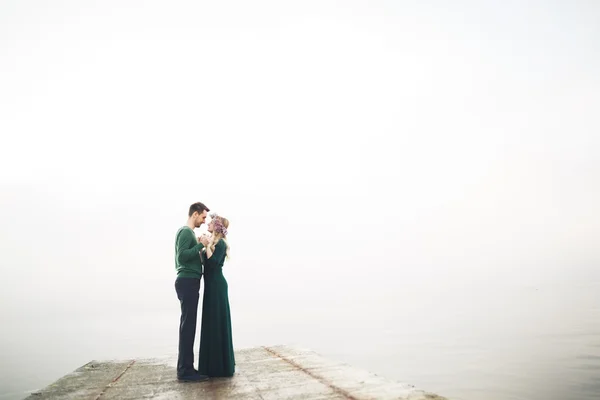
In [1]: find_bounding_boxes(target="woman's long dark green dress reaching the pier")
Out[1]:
[198,239,235,377]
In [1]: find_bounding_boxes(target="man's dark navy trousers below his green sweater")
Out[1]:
[175,278,200,377]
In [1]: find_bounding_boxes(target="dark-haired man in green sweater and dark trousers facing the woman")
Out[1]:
[175,202,210,382]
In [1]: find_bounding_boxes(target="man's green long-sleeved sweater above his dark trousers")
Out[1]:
[175,226,204,279]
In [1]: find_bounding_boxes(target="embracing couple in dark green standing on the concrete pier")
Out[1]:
[175,203,235,382]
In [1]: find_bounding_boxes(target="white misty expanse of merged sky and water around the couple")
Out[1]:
[0,0,600,400]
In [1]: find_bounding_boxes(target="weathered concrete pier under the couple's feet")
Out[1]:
[27,346,446,400]
